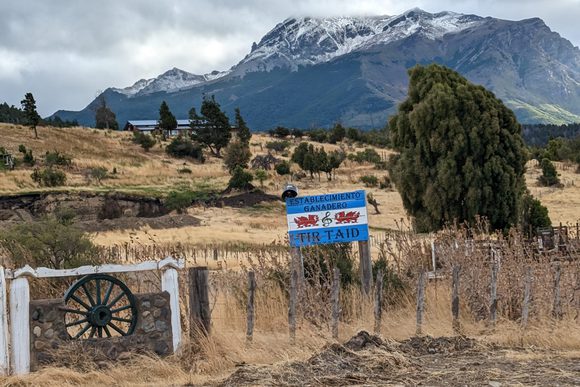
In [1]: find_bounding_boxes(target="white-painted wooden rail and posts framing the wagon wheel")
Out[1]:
[0,257,185,375]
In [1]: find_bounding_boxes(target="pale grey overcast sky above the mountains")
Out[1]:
[0,0,580,116]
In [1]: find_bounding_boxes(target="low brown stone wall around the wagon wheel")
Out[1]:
[30,292,173,370]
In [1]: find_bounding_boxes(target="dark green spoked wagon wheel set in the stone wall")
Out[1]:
[64,274,137,339]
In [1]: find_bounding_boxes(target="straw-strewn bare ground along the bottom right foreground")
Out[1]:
[216,332,580,386]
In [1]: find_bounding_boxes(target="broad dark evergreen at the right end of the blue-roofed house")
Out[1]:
[190,96,232,157]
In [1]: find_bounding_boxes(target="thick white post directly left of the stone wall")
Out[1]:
[10,276,30,375]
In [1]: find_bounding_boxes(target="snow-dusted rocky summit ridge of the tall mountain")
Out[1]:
[236,8,484,73]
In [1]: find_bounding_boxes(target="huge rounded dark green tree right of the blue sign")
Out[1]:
[389,64,527,231]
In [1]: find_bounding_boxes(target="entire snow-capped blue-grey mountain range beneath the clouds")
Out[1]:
[55,9,580,130]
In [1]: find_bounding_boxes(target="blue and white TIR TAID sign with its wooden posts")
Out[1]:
[286,190,372,295]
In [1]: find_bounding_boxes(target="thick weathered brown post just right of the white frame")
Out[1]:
[188,267,211,338]
